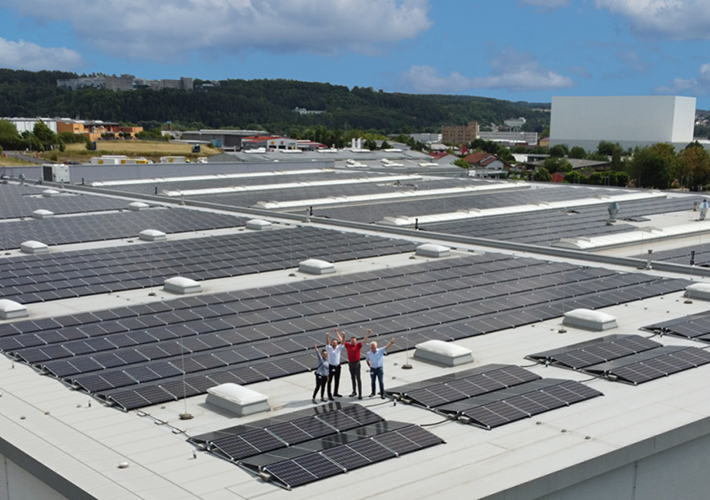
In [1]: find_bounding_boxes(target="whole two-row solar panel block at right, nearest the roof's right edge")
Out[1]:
[528,335,710,385]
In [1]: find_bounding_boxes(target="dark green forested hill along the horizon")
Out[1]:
[0,69,549,133]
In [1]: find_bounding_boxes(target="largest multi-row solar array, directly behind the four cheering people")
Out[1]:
[0,254,686,410]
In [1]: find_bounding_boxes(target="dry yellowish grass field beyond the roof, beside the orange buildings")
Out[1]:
[40,141,220,163]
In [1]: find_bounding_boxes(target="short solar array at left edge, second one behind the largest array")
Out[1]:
[0,208,245,250]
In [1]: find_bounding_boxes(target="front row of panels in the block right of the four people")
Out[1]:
[437,379,602,430]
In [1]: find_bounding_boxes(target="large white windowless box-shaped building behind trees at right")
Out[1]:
[550,96,695,150]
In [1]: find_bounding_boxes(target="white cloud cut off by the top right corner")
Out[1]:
[596,0,710,40]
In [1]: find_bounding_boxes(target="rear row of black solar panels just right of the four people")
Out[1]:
[387,365,540,408]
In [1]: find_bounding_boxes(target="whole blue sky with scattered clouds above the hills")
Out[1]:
[0,0,710,110]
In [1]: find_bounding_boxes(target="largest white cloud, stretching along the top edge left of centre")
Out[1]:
[4,0,432,60]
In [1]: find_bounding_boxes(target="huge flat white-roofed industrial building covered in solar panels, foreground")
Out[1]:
[0,162,710,500]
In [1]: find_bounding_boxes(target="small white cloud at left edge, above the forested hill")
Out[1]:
[0,38,85,71]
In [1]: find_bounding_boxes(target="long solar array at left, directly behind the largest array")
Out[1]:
[0,227,414,304]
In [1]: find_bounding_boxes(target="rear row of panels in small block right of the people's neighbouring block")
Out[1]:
[526,335,662,370]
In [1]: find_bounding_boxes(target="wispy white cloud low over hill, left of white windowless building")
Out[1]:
[401,47,576,93]
